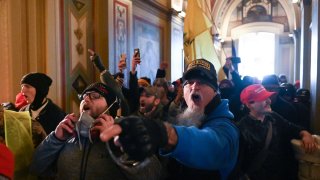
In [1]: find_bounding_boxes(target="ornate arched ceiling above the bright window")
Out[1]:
[212,0,300,39]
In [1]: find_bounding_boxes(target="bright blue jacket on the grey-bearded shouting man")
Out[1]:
[160,99,239,179]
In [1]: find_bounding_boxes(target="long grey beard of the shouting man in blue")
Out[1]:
[176,108,206,127]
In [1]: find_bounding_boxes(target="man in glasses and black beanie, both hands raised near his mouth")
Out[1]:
[30,53,160,180]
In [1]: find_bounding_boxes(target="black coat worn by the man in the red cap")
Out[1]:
[238,112,303,180]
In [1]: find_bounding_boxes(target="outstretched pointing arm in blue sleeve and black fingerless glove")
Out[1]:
[100,117,239,174]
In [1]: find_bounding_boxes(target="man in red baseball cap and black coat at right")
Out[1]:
[237,84,317,180]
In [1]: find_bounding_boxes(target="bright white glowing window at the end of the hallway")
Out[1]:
[239,32,275,80]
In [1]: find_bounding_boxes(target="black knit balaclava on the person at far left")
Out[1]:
[21,73,52,110]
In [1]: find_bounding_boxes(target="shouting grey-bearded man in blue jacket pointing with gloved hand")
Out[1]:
[100,59,239,179]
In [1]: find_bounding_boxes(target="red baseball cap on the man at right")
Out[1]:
[240,84,275,104]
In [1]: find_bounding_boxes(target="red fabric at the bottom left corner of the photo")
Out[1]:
[0,144,14,179]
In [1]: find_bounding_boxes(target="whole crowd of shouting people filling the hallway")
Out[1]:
[0,50,317,180]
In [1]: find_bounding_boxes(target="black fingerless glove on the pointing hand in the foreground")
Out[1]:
[119,116,168,161]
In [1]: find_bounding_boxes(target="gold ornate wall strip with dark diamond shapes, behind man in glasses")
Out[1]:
[61,0,95,112]
